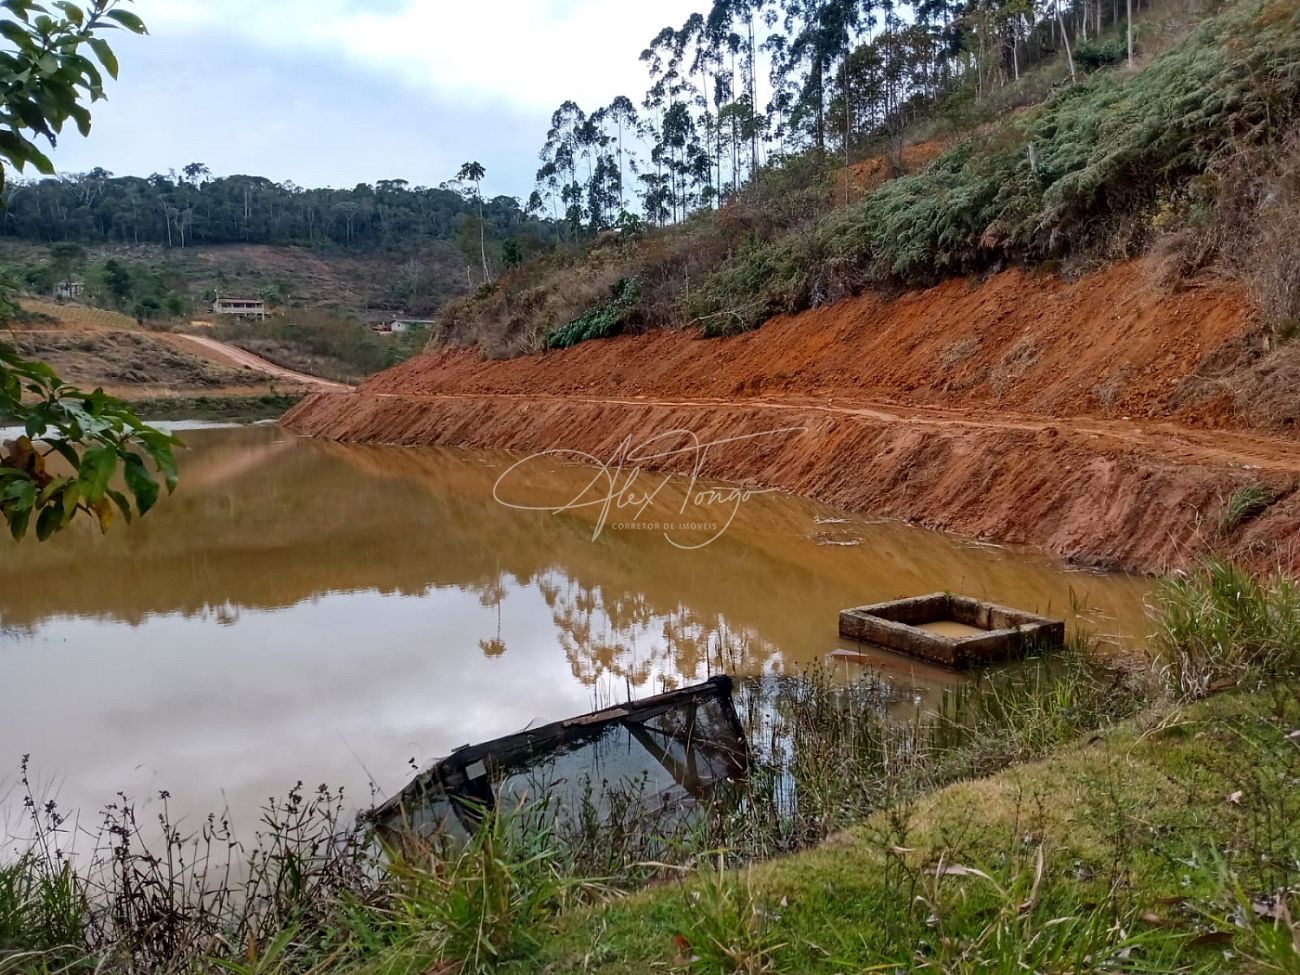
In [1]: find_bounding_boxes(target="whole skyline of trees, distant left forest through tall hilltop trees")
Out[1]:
[0,0,1152,256]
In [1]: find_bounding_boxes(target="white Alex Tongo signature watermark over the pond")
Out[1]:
[491,426,807,550]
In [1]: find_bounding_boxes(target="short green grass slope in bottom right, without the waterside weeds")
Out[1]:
[517,685,1300,974]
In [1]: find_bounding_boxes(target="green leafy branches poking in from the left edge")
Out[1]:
[0,0,179,540]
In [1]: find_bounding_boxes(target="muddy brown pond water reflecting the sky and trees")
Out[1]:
[0,426,1147,826]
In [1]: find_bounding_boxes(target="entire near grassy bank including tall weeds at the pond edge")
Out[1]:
[0,566,1300,975]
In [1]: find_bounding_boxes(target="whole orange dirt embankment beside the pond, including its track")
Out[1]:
[286,264,1300,571]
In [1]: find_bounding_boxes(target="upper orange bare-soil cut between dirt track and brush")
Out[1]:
[361,263,1249,420]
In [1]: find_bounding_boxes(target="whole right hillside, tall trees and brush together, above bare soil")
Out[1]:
[438,0,1300,356]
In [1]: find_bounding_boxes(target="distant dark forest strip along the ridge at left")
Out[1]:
[0,163,555,265]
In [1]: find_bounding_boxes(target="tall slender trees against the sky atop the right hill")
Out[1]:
[528,0,1149,234]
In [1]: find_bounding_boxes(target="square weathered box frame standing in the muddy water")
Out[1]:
[840,593,1065,668]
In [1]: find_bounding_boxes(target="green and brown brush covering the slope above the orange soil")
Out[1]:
[442,0,1300,354]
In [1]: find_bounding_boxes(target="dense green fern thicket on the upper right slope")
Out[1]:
[686,0,1300,333]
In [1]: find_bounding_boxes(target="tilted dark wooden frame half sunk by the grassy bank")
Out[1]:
[371,676,749,835]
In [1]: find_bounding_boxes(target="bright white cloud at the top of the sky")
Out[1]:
[137,0,705,111]
